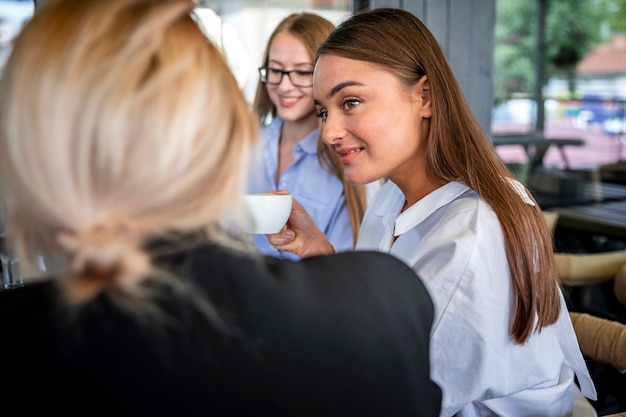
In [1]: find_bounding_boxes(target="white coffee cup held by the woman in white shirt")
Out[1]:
[244,193,293,234]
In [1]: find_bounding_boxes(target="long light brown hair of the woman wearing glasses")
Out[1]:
[253,12,366,243]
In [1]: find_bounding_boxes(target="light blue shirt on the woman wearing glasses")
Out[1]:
[248,117,354,259]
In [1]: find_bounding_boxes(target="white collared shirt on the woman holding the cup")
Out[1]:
[356,181,596,417]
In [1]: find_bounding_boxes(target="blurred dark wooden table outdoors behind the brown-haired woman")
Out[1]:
[491,133,585,171]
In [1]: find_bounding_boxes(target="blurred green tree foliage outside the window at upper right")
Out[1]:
[494,0,626,103]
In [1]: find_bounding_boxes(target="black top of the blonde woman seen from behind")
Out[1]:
[0,246,441,417]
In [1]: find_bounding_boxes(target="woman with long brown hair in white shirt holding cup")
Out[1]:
[270,8,595,416]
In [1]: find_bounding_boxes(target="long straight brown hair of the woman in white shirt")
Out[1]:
[315,8,560,343]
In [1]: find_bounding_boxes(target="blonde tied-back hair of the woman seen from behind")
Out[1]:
[0,0,258,303]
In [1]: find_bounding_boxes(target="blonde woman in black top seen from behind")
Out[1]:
[0,0,441,416]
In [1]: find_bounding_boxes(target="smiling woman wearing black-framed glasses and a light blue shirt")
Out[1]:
[248,12,377,259]
